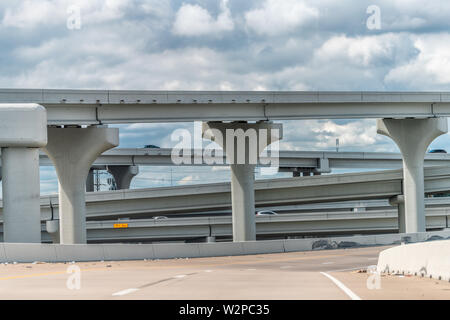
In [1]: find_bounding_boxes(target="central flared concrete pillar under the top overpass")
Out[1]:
[203,122,282,242]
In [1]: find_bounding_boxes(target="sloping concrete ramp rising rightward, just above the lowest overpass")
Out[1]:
[0,167,450,242]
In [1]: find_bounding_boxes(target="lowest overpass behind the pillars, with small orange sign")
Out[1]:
[0,204,450,243]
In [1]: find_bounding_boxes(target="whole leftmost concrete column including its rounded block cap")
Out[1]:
[0,104,47,243]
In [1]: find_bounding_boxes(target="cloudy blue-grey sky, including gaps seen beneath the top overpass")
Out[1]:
[0,0,450,193]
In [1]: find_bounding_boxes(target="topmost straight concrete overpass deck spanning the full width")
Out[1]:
[0,89,450,125]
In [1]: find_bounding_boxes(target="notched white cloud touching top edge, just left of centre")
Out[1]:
[173,0,234,36]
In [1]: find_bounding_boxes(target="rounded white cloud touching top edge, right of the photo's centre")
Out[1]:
[245,0,319,36]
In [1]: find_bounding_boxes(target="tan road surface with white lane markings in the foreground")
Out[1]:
[0,247,450,300]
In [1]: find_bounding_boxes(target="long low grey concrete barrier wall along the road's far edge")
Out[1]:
[0,230,450,262]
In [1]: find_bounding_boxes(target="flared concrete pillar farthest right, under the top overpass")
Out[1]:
[377,118,448,233]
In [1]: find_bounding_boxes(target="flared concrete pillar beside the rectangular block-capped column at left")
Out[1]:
[44,127,119,244]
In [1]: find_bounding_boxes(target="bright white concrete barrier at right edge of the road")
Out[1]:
[377,237,450,281]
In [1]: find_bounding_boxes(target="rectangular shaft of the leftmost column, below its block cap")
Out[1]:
[2,148,41,243]
